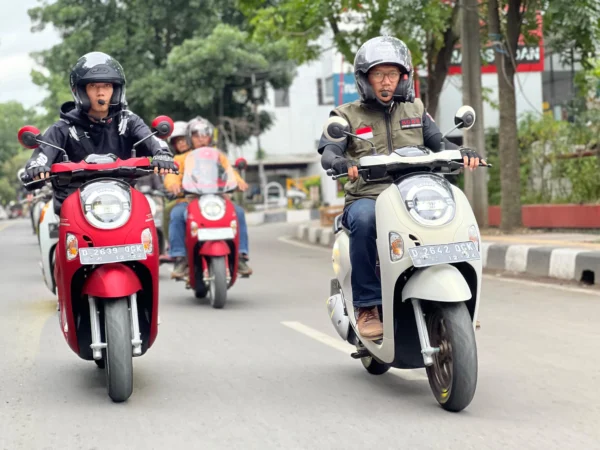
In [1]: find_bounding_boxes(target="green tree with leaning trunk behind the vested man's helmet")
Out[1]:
[240,0,459,115]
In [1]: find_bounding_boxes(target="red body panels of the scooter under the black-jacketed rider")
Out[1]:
[53,183,159,359]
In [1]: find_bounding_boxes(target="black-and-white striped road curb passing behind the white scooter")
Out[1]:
[296,224,600,284]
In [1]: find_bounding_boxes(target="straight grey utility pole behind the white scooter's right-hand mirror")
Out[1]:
[460,0,488,227]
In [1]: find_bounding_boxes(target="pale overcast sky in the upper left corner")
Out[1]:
[0,0,60,106]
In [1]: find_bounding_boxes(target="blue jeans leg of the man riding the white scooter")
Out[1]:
[342,198,381,308]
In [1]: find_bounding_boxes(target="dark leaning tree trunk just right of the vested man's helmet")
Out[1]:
[427,3,460,117]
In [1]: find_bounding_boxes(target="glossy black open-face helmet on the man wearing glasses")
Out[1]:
[354,36,415,103]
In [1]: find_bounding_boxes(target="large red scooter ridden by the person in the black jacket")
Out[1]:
[18,116,173,402]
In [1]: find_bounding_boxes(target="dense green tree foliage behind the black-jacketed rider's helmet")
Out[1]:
[29,0,292,144]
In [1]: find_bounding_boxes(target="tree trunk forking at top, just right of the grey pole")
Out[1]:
[488,0,522,232]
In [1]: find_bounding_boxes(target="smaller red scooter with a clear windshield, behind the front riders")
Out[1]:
[182,147,246,308]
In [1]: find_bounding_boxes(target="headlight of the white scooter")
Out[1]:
[397,175,456,227]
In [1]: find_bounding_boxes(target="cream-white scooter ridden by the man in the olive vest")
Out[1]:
[325,106,482,411]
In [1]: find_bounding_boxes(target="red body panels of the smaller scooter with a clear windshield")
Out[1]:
[185,194,240,288]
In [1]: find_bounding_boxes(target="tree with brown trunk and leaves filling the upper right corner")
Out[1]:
[487,0,600,231]
